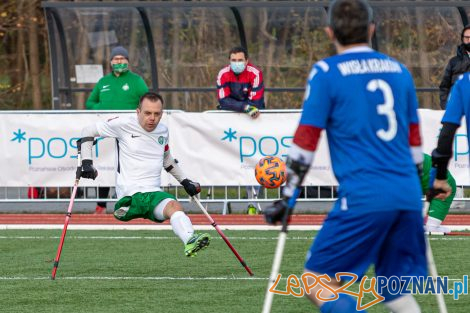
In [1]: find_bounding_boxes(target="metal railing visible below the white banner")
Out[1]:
[0,186,470,214]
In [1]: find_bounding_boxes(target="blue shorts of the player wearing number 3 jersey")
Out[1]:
[305,205,427,279]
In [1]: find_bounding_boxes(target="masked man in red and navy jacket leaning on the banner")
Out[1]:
[217,47,264,118]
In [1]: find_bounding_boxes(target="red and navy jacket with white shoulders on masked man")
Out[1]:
[217,63,264,112]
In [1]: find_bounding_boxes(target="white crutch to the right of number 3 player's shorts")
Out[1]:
[423,167,447,313]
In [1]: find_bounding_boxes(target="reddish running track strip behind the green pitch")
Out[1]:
[0,214,470,225]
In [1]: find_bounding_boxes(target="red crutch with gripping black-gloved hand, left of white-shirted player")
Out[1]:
[51,137,98,279]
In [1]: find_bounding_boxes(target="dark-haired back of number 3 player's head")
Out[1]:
[328,0,372,45]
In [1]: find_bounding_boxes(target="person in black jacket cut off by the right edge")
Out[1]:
[439,25,470,110]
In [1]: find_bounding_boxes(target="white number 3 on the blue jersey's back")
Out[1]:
[367,79,397,141]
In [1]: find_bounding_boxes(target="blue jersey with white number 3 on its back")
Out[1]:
[300,46,422,212]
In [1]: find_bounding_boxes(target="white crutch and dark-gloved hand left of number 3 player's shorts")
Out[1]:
[262,188,300,313]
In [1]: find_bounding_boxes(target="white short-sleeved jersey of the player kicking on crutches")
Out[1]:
[96,116,168,198]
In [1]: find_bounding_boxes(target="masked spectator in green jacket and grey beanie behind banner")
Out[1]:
[86,46,148,214]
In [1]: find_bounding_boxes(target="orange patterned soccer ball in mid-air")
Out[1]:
[255,156,287,189]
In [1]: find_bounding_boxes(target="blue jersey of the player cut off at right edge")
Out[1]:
[442,73,470,147]
